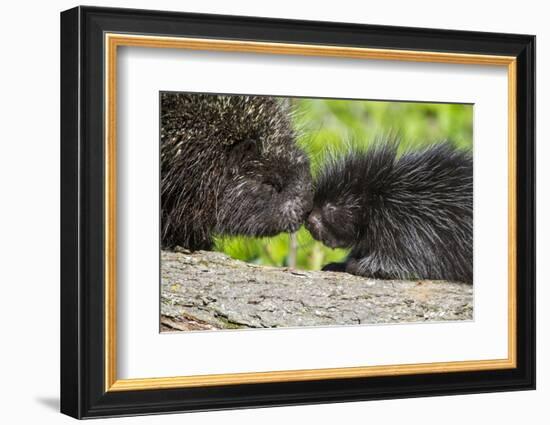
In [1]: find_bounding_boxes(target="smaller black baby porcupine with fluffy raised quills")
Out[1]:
[306,142,473,283]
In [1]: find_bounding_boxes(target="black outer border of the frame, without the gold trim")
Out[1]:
[61,6,535,418]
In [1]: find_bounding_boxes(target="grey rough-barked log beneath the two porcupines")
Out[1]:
[161,250,473,331]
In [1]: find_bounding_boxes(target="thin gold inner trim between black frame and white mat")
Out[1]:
[104,33,517,391]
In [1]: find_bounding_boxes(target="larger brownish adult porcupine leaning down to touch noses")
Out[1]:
[160,92,312,250]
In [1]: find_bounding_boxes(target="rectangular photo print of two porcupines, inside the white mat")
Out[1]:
[160,92,474,332]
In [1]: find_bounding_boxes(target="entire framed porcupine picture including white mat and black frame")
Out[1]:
[61,7,535,418]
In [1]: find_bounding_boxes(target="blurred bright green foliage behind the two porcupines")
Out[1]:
[215,98,473,270]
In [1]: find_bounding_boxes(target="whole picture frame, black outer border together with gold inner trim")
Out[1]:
[61,7,535,418]
